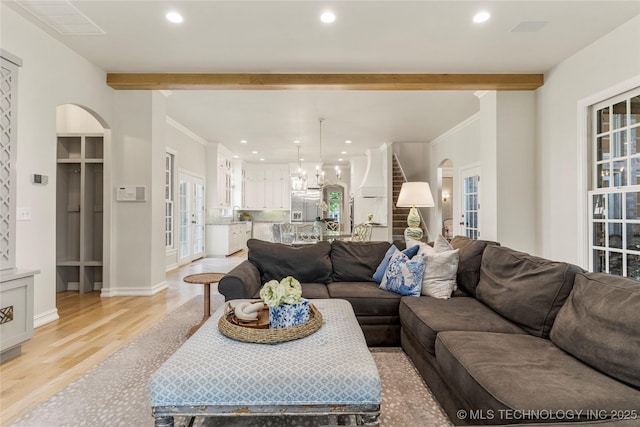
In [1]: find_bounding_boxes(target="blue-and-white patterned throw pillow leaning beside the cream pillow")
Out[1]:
[380,251,425,296]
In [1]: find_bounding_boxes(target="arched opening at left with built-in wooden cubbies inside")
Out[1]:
[56,104,111,293]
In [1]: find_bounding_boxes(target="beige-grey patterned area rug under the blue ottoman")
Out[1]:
[12,296,452,427]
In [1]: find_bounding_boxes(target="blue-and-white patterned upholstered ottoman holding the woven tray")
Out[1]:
[148,299,381,427]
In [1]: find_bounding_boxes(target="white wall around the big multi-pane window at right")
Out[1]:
[535,16,640,268]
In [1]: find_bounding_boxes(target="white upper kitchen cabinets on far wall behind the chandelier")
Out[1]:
[243,163,291,209]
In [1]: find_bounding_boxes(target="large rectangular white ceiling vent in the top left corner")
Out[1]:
[16,0,106,35]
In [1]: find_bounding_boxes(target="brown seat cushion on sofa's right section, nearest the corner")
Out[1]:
[400,297,526,354]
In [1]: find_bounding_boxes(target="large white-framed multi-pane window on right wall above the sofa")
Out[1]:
[588,88,640,280]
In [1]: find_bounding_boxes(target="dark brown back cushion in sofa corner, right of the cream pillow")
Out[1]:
[451,236,500,297]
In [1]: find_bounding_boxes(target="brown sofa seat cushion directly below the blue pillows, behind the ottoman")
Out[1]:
[327,282,402,316]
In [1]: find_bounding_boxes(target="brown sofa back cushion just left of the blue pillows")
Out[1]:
[331,240,391,282]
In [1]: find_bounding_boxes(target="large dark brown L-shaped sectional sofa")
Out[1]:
[219,237,640,426]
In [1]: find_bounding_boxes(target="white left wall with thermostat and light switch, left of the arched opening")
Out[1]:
[0,2,113,326]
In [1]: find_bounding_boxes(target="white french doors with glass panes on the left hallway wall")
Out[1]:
[178,172,204,265]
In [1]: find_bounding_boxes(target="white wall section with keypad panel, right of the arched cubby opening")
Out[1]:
[110,91,167,296]
